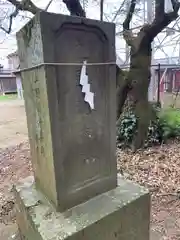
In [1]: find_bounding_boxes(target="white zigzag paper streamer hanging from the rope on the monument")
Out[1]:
[80,61,94,109]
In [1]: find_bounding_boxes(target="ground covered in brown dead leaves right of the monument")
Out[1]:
[117,144,180,240]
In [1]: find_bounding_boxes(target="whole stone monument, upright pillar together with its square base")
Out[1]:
[14,12,150,240]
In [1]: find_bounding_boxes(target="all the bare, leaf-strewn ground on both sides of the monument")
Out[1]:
[0,98,180,240]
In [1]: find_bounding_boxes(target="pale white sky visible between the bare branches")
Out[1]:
[0,0,180,68]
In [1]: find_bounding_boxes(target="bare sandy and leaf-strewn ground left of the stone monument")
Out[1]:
[0,100,31,240]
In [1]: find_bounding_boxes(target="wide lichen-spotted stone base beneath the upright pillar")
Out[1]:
[14,176,150,240]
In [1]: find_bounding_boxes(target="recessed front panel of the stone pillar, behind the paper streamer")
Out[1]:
[55,24,111,191]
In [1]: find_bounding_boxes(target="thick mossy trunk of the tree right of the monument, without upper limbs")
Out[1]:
[117,34,152,150]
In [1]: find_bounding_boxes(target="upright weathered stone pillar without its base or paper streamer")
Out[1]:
[17,12,117,211]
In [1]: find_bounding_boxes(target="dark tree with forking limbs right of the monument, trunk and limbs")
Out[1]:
[117,0,180,150]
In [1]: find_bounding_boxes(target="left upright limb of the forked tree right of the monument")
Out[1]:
[123,0,136,47]
